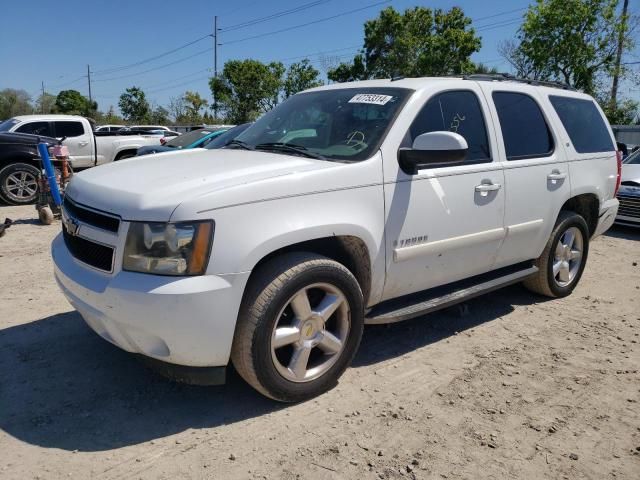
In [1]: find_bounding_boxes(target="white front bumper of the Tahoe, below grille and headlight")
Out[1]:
[51,234,249,367]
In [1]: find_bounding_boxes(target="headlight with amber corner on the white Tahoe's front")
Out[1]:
[122,221,213,275]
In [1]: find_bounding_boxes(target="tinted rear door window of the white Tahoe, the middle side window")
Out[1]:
[493,92,554,160]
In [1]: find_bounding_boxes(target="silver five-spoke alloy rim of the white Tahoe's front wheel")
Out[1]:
[271,283,351,382]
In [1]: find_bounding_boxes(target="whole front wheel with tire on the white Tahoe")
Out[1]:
[231,253,364,402]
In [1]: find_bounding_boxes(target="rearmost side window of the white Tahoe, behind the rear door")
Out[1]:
[549,95,616,153]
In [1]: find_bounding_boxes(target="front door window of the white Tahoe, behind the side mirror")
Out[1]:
[409,90,491,163]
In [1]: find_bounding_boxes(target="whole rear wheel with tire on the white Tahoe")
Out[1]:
[524,211,589,298]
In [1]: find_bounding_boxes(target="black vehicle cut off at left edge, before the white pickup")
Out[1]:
[0,133,58,203]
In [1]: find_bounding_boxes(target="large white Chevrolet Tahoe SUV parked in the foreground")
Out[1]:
[52,75,621,401]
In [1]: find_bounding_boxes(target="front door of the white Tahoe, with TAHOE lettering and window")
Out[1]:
[382,86,505,300]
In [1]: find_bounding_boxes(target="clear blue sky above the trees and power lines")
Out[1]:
[0,0,640,111]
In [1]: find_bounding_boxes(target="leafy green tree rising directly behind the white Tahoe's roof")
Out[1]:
[328,7,481,81]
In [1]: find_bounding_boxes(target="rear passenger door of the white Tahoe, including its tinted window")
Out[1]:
[479,82,571,268]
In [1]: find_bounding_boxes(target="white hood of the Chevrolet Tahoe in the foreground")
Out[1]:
[66,149,345,222]
